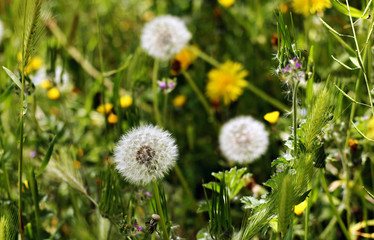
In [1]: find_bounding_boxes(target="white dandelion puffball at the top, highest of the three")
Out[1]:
[141,15,191,60]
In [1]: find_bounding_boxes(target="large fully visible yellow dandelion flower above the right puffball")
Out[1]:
[206,60,248,105]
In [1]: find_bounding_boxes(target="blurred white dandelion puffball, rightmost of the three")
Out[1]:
[219,116,269,164]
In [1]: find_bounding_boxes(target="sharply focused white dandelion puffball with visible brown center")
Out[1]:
[114,125,178,185]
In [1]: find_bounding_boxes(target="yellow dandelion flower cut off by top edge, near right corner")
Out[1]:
[292,0,331,16]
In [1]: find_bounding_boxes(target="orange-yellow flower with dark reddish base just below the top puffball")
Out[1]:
[171,46,197,75]
